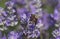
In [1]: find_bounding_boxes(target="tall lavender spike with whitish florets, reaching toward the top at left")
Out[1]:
[4,1,18,26]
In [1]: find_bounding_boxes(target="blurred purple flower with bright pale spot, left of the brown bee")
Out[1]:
[17,8,30,21]
